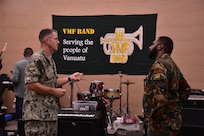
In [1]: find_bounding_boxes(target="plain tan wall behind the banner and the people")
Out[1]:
[0,0,204,114]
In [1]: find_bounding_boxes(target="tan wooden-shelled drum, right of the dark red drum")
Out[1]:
[103,89,120,99]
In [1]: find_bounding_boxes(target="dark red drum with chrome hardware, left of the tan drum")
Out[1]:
[89,80,104,94]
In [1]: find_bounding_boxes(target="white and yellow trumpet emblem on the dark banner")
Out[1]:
[100,26,143,64]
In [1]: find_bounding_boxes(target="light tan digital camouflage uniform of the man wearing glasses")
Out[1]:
[23,51,59,136]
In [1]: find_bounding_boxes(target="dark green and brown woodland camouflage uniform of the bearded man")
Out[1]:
[143,54,191,136]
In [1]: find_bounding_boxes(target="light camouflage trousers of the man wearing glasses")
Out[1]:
[24,120,57,136]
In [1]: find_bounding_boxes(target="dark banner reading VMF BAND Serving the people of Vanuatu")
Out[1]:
[52,14,157,75]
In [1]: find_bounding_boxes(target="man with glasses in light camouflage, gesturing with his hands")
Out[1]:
[23,29,83,136]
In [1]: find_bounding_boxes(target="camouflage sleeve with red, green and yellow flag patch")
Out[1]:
[147,63,168,120]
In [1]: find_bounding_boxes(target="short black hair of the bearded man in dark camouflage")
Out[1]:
[158,36,174,54]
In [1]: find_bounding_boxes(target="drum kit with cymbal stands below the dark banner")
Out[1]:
[71,71,135,129]
